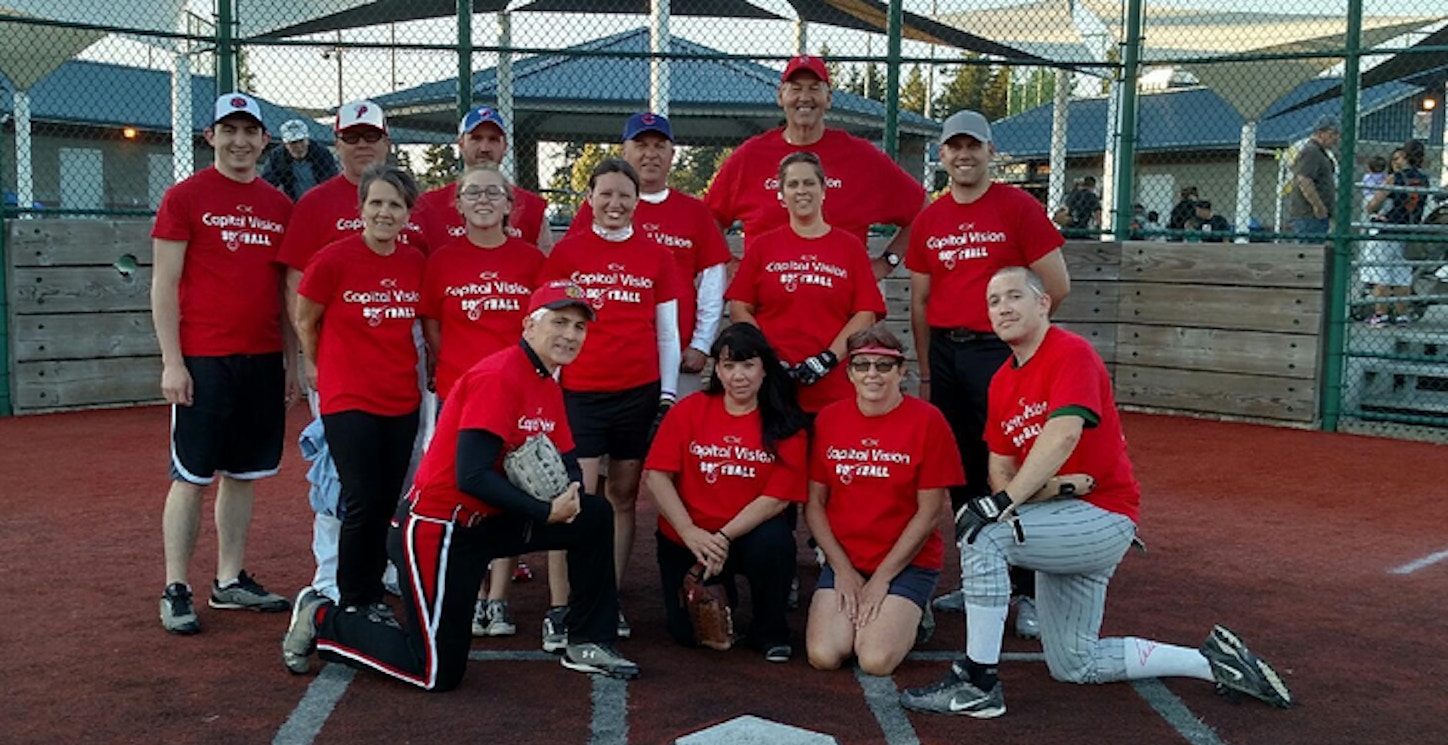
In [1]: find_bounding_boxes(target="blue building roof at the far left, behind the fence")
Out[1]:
[0,59,332,143]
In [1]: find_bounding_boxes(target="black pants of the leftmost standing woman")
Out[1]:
[321,409,417,608]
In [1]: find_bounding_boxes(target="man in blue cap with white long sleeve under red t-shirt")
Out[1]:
[568,111,733,398]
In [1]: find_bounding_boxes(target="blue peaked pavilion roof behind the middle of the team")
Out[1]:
[374,29,940,135]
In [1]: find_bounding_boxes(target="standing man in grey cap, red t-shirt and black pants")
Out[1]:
[905,110,1072,638]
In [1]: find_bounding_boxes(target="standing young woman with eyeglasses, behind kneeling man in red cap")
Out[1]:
[421,162,553,637]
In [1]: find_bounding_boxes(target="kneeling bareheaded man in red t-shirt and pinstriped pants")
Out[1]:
[901,266,1293,719]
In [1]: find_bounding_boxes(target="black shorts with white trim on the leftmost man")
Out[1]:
[171,352,287,485]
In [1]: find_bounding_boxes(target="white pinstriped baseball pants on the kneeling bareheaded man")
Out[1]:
[960,499,1137,683]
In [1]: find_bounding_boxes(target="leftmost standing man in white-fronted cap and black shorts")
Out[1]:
[151,93,297,634]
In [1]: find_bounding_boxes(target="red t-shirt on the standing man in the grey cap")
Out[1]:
[905,184,1064,331]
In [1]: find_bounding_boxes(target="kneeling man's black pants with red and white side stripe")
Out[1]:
[317,495,618,691]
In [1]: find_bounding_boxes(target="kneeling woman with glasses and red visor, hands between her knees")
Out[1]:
[805,325,966,676]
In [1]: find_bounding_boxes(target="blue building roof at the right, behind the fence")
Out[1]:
[990,78,1422,158]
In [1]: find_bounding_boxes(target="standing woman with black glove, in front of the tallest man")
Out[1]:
[724,150,885,412]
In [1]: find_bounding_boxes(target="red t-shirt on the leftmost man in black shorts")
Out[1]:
[151,168,291,357]
